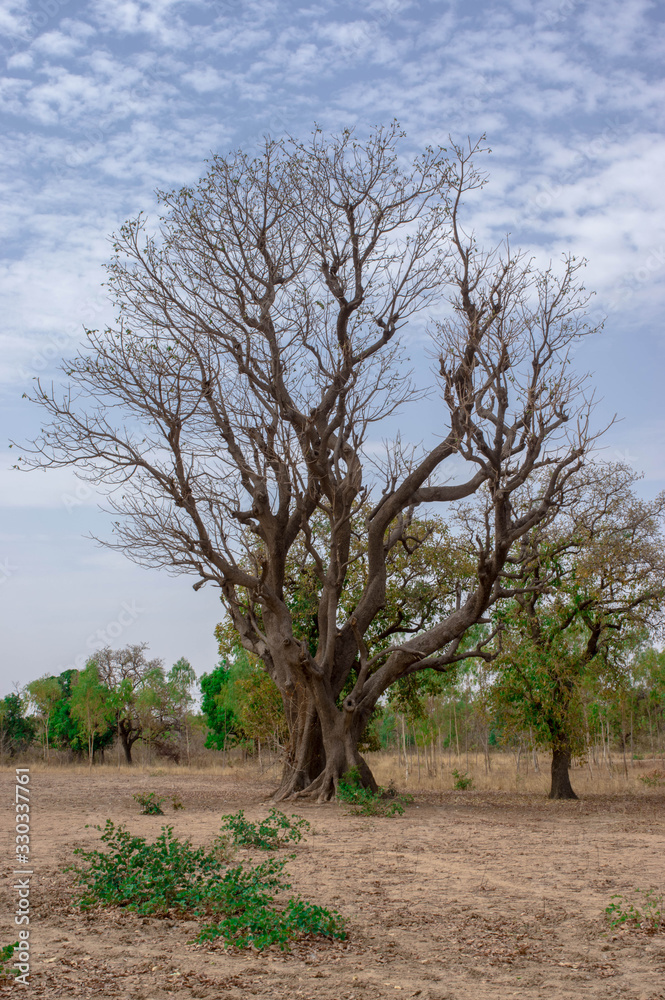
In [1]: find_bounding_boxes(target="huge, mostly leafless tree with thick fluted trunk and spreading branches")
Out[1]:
[23,126,600,799]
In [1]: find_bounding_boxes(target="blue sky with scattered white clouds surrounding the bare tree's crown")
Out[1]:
[0,0,665,694]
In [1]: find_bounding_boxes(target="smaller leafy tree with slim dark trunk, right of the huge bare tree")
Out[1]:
[494,463,665,798]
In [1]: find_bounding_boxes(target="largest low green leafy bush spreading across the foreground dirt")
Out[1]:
[68,820,346,951]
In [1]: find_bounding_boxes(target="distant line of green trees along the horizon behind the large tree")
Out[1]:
[0,644,665,768]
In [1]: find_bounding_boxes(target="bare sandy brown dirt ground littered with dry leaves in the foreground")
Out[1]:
[0,767,665,1000]
